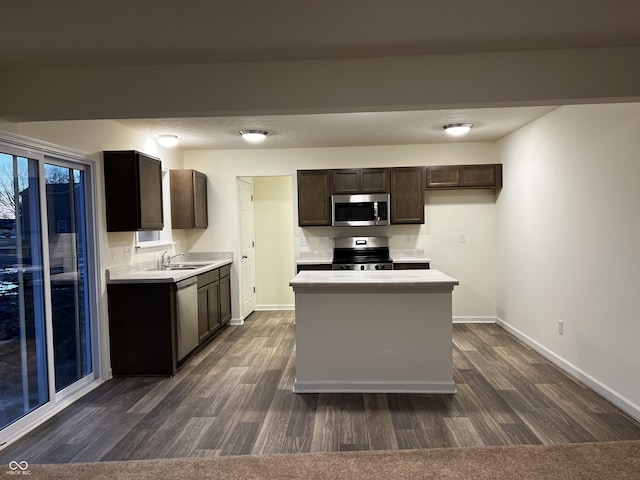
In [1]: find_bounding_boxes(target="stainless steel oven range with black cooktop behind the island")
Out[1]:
[331,237,393,270]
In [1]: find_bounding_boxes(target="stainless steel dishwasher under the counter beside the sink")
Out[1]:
[176,277,199,361]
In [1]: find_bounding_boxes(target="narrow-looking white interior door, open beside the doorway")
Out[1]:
[238,179,256,318]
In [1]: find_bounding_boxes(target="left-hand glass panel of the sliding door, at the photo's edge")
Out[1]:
[0,152,49,429]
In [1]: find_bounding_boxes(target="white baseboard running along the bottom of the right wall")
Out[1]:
[496,318,640,421]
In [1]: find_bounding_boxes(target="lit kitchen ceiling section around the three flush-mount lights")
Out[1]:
[119,107,555,150]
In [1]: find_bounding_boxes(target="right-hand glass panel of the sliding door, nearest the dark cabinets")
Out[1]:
[44,163,93,392]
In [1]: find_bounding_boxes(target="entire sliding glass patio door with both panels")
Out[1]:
[0,147,95,436]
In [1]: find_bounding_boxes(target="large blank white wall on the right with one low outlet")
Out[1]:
[497,104,640,418]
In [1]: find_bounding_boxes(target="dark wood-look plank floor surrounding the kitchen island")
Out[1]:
[0,312,640,464]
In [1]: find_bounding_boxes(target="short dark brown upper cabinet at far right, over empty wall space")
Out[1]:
[426,164,502,189]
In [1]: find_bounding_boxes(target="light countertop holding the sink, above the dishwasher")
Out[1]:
[107,252,233,283]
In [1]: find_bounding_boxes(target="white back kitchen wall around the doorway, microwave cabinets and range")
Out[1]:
[184,143,496,319]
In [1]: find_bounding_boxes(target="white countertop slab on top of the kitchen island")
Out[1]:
[289,270,459,292]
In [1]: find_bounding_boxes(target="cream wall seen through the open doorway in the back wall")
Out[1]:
[253,177,296,310]
